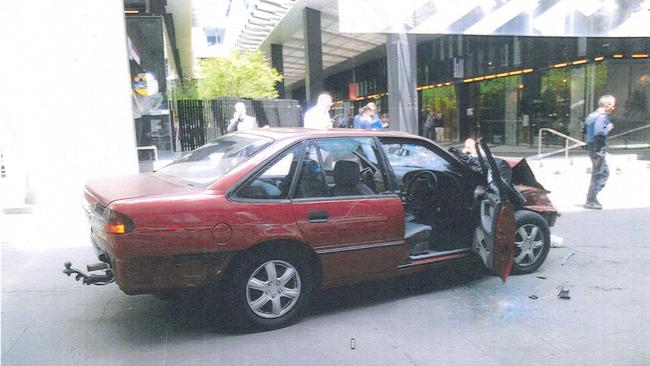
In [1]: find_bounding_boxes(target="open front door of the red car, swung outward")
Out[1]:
[472,139,515,282]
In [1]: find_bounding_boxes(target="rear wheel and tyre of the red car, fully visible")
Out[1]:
[229,248,314,331]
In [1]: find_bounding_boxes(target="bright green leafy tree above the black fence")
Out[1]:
[197,51,282,99]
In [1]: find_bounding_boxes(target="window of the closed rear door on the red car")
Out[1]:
[296,137,386,197]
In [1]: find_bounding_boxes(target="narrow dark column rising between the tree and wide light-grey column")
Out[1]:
[303,8,323,106]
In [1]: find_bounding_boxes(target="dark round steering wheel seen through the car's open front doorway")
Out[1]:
[403,170,438,216]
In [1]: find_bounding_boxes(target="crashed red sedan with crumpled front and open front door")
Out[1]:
[64,129,557,329]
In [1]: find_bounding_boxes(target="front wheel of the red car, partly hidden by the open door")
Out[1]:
[512,210,551,274]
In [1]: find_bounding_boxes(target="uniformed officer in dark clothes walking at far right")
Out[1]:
[584,95,616,210]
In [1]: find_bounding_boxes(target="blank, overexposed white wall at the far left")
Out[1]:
[0,0,138,244]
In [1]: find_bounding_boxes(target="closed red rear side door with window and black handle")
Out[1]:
[292,137,407,285]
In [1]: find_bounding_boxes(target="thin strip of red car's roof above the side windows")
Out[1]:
[237,127,421,140]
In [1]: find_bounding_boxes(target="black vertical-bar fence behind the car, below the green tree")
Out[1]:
[176,98,302,151]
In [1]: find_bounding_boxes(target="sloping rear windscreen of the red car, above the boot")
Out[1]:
[156,134,273,186]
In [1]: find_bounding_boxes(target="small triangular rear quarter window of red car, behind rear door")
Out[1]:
[235,145,302,199]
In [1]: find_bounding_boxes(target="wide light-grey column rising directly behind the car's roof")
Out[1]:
[386,33,418,134]
